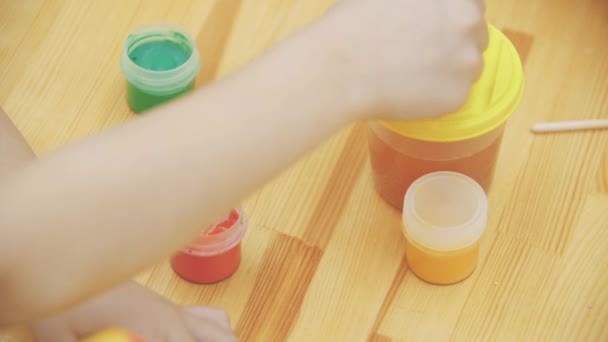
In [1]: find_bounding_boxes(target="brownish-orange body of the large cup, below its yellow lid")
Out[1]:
[368,127,502,209]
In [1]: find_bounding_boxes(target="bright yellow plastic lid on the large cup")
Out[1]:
[380,25,524,142]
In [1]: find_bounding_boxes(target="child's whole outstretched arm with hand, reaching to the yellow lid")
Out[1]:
[0,0,486,325]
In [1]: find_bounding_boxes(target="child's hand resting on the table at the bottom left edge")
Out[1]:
[32,283,236,342]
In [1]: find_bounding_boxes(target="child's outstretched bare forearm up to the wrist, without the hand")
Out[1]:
[0,22,352,322]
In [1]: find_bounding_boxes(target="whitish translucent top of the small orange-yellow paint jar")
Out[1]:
[403,171,488,251]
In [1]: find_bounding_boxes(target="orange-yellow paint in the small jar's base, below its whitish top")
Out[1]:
[405,236,479,285]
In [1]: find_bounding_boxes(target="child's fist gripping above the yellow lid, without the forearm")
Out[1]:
[319,0,487,120]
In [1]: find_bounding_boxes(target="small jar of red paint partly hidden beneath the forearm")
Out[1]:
[171,208,247,284]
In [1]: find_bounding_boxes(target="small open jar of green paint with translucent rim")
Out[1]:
[120,22,201,113]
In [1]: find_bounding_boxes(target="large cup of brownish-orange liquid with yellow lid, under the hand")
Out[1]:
[368,26,524,209]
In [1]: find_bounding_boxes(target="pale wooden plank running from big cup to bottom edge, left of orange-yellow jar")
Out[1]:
[290,163,404,341]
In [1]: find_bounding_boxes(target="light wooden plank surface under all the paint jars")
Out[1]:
[0,0,608,341]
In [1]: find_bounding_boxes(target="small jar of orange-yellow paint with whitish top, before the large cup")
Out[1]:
[403,171,488,285]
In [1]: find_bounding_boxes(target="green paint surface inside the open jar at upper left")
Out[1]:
[129,40,192,71]
